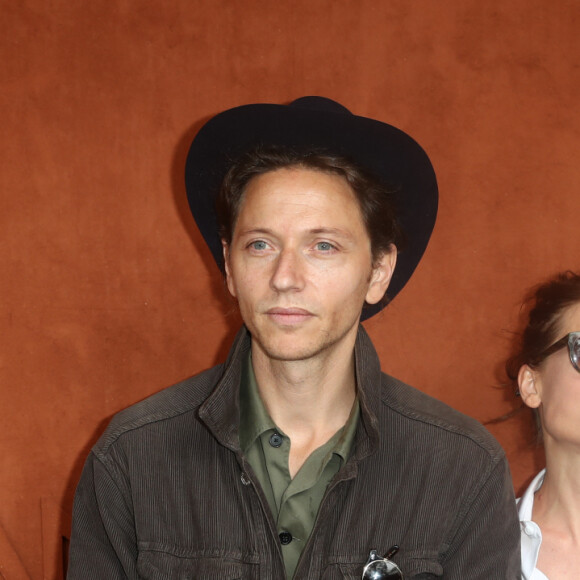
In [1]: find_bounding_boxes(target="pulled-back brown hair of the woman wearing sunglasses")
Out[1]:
[505,270,580,387]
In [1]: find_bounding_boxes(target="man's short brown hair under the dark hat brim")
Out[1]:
[216,147,403,263]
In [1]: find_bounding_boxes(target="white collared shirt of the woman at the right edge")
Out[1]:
[516,469,548,580]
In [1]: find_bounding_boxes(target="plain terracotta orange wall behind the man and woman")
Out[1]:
[0,0,580,580]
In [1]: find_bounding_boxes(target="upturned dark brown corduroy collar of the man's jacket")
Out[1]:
[199,326,381,462]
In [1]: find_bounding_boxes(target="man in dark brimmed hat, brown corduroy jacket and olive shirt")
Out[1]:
[68,97,520,580]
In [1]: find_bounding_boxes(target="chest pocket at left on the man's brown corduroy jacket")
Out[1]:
[137,551,260,580]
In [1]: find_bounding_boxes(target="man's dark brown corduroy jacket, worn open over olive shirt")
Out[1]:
[68,327,520,580]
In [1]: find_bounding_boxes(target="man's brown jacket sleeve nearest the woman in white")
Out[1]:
[443,457,521,580]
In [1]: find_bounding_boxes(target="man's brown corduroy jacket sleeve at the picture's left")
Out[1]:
[67,453,139,580]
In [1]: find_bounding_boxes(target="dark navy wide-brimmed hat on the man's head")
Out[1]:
[185,97,438,320]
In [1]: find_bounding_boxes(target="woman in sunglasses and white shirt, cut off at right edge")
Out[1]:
[507,272,580,580]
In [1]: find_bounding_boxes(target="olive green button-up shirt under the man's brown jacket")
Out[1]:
[240,355,359,579]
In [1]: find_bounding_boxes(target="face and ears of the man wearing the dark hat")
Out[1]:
[224,168,396,361]
